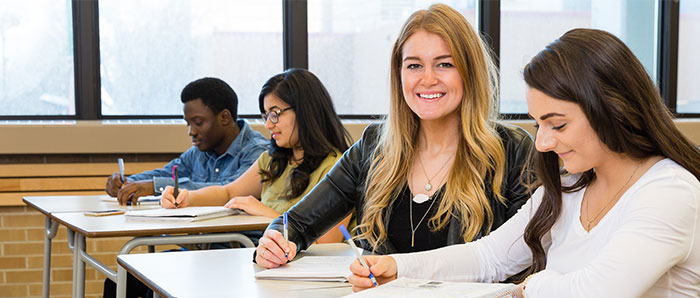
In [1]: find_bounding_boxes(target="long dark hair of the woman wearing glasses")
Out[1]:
[258,68,351,200]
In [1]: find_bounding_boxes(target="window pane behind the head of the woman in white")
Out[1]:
[500,0,658,113]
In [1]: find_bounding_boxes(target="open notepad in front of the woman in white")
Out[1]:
[345,277,515,298]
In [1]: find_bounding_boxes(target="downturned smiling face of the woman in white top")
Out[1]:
[527,88,611,173]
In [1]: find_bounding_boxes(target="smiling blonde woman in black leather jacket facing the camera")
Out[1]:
[255,5,532,268]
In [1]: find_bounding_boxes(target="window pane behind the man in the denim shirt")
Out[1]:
[99,0,283,115]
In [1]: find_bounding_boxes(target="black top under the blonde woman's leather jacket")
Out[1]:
[387,186,449,253]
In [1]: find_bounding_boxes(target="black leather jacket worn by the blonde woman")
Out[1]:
[267,124,532,254]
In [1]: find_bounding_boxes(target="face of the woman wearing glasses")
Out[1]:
[263,93,299,148]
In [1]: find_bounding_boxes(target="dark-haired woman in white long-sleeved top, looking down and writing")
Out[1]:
[351,29,700,298]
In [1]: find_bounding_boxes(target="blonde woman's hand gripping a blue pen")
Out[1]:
[255,230,297,269]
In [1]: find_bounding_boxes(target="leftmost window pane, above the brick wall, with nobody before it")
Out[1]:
[0,0,75,116]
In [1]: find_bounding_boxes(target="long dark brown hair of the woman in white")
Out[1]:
[523,29,700,273]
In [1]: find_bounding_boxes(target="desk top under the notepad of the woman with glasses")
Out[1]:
[49,212,270,238]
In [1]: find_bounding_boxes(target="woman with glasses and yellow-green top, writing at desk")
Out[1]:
[161,69,351,242]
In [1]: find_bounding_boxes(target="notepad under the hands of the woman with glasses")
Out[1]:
[125,206,243,221]
